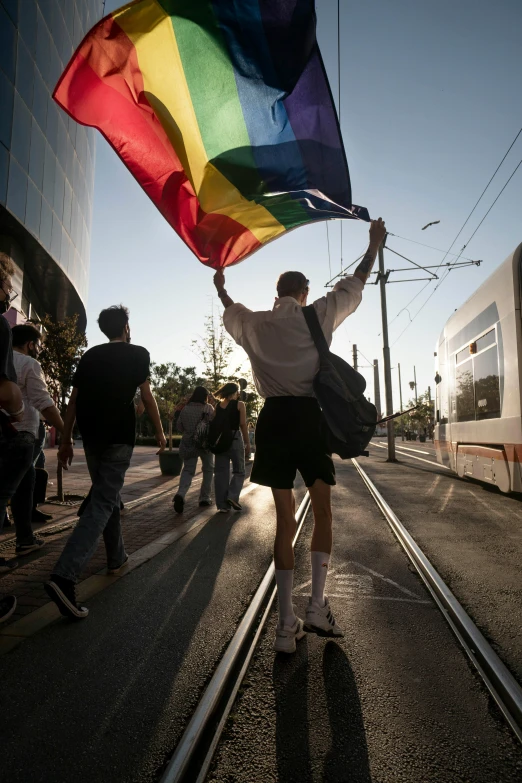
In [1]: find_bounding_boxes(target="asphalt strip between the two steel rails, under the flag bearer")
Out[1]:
[208,463,522,783]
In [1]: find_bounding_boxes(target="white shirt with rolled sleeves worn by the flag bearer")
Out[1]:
[223,276,364,399]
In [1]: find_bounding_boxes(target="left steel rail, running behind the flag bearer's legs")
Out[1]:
[161,492,310,783]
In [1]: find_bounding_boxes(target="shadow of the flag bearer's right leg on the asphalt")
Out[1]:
[322,641,372,783]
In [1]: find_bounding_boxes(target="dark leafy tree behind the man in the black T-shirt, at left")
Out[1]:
[38,315,87,416]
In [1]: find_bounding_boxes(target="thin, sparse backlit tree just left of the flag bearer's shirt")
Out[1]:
[191,313,241,391]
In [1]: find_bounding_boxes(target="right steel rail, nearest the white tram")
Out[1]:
[352,459,522,742]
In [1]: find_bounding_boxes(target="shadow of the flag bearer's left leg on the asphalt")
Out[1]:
[272,637,312,783]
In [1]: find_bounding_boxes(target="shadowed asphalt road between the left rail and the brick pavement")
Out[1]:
[0,487,303,783]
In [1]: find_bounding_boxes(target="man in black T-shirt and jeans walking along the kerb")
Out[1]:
[45,305,166,618]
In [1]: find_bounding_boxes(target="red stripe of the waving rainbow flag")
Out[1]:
[53,17,260,269]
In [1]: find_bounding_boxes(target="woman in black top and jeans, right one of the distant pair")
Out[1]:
[213,383,250,514]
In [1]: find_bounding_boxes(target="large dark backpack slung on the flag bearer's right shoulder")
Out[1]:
[303,305,377,459]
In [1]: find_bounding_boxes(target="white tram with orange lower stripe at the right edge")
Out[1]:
[434,244,522,492]
